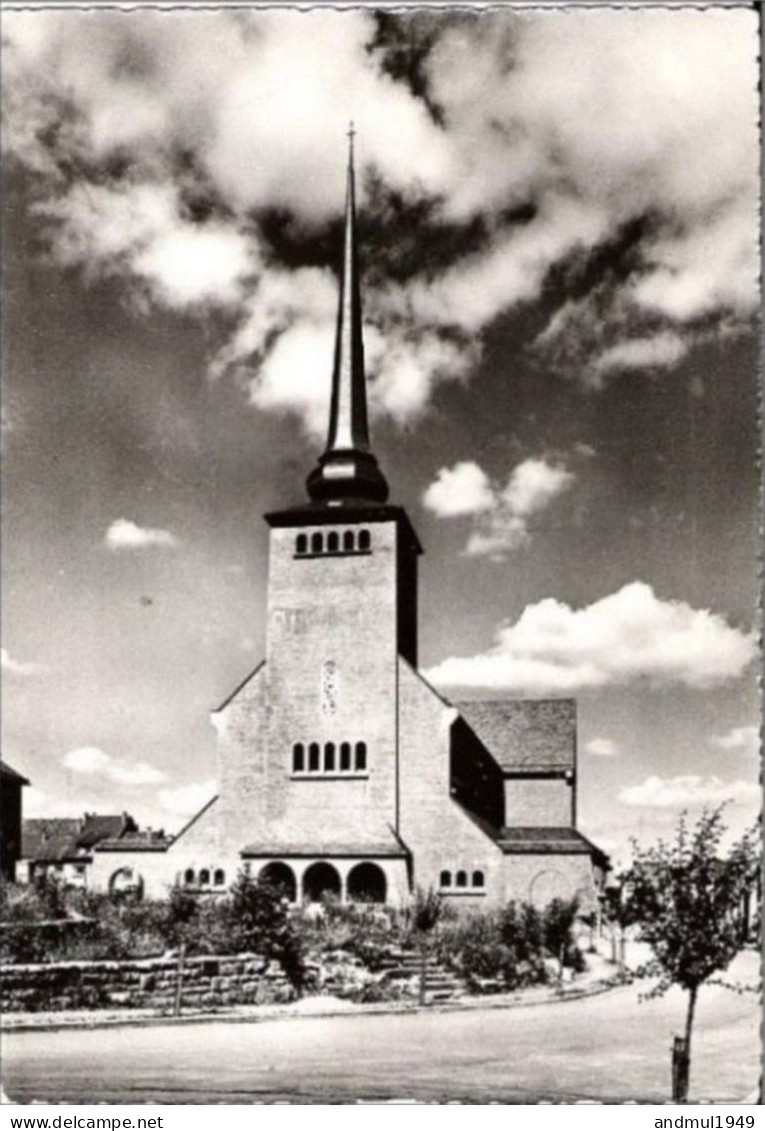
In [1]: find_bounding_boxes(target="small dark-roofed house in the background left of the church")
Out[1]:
[18,813,138,888]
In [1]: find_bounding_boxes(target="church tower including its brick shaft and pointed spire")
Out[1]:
[211,128,422,877]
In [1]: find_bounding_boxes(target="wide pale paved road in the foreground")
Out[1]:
[2,961,760,1103]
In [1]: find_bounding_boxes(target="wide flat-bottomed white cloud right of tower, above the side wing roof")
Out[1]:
[426,581,756,696]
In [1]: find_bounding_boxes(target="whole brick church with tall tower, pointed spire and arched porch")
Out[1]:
[92,145,608,909]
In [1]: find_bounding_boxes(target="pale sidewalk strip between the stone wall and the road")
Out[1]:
[1,955,622,1033]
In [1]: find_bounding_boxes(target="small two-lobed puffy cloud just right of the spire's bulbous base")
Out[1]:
[422,458,575,561]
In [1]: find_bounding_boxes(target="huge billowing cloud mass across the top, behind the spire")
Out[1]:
[3,9,758,432]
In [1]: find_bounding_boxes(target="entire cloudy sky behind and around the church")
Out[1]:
[2,6,760,862]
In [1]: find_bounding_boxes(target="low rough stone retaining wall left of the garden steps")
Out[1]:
[0,955,295,1012]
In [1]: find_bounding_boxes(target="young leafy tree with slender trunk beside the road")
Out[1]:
[624,805,758,1103]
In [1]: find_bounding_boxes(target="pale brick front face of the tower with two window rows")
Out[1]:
[256,512,398,845]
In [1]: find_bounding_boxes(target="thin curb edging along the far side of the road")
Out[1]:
[0,979,626,1034]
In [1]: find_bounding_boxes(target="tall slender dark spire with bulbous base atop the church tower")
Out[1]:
[307,122,388,503]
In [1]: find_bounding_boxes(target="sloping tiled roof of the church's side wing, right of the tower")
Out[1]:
[454,699,576,774]
